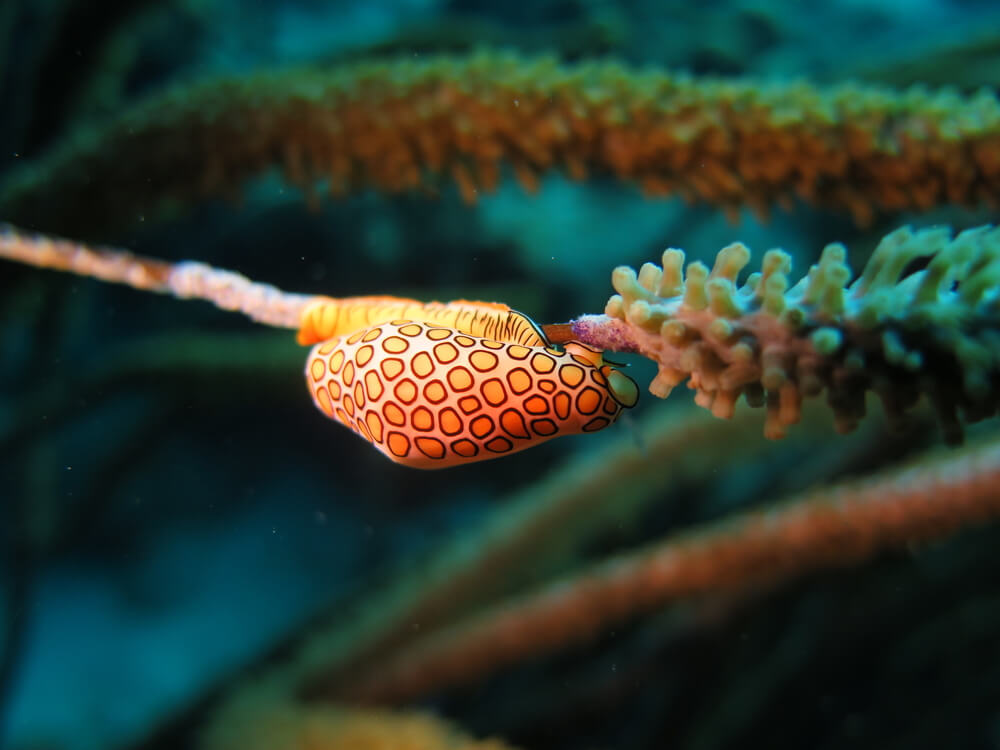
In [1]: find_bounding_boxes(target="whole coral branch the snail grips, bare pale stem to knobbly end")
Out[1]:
[0,226,1000,450]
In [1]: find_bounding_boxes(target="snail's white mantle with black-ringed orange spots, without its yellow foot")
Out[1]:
[305,320,638,469]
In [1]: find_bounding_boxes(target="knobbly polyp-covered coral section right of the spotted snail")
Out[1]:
[568,226,1000,442]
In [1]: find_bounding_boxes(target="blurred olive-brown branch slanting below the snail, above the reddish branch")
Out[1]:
[293,400,919,697]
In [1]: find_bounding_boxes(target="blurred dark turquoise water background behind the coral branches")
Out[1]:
[0,0,1000,750]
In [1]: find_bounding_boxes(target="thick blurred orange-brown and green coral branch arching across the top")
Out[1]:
[0,54,1000,234]
